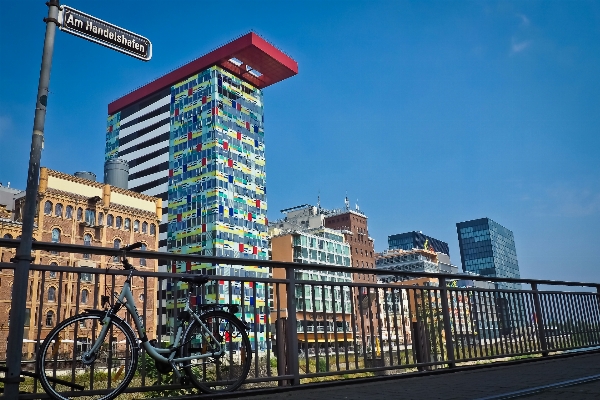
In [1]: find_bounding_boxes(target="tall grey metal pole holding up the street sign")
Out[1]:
[4,0,60,399]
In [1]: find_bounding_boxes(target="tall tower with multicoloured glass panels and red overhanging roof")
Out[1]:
[105,33,298,346]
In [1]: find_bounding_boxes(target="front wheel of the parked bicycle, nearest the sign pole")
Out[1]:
[37,312,138,400]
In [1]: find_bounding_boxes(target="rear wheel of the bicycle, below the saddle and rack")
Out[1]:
[181,311,252,393]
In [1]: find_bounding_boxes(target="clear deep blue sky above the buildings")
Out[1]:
[0,0,600,282]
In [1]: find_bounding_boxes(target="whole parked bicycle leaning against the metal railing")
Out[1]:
[36,243,252,400]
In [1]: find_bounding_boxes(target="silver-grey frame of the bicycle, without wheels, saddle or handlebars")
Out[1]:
[84,271,225,365]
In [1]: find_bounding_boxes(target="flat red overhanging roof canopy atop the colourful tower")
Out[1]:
[108,32,298,115]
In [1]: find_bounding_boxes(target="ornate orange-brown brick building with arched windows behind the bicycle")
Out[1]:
[0,168,162,358]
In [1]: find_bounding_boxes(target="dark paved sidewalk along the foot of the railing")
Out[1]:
[232,353,600,400]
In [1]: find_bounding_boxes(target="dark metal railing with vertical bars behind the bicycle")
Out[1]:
[0,239,600,399]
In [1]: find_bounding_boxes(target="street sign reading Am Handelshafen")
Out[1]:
[58,6,152,61]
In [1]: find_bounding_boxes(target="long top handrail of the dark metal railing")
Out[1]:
[0,238,600,290]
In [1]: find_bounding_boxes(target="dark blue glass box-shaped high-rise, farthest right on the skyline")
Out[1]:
[456,218,521,289]
